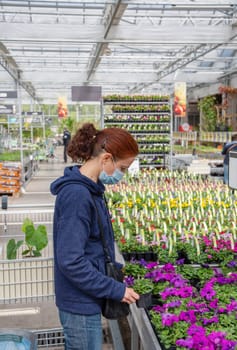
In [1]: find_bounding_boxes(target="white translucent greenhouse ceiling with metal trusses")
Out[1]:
[0,0,237,104]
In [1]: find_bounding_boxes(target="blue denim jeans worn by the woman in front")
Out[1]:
[59,310,102,350]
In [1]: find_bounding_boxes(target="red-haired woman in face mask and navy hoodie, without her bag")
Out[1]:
[51,124,139,350]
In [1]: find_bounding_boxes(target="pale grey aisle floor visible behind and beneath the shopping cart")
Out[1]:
[3,146,114,350]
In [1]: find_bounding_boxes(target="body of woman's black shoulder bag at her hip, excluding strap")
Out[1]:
[102,262,129,320]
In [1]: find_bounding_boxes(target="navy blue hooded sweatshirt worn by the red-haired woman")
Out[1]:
[50,166,126,315]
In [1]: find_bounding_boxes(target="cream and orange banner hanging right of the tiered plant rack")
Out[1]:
[174,82,187,117]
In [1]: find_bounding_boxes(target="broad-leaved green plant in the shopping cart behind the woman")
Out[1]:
[7,218,48,259]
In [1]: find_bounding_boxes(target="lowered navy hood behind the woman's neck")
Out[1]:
[50,165,105,195]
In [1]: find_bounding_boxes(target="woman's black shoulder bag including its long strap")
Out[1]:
[92,197,130,320]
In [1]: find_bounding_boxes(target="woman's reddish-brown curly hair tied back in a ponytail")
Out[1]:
[67,123,138,162]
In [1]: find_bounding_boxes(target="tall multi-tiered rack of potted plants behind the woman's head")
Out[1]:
[103,95,172,168]
